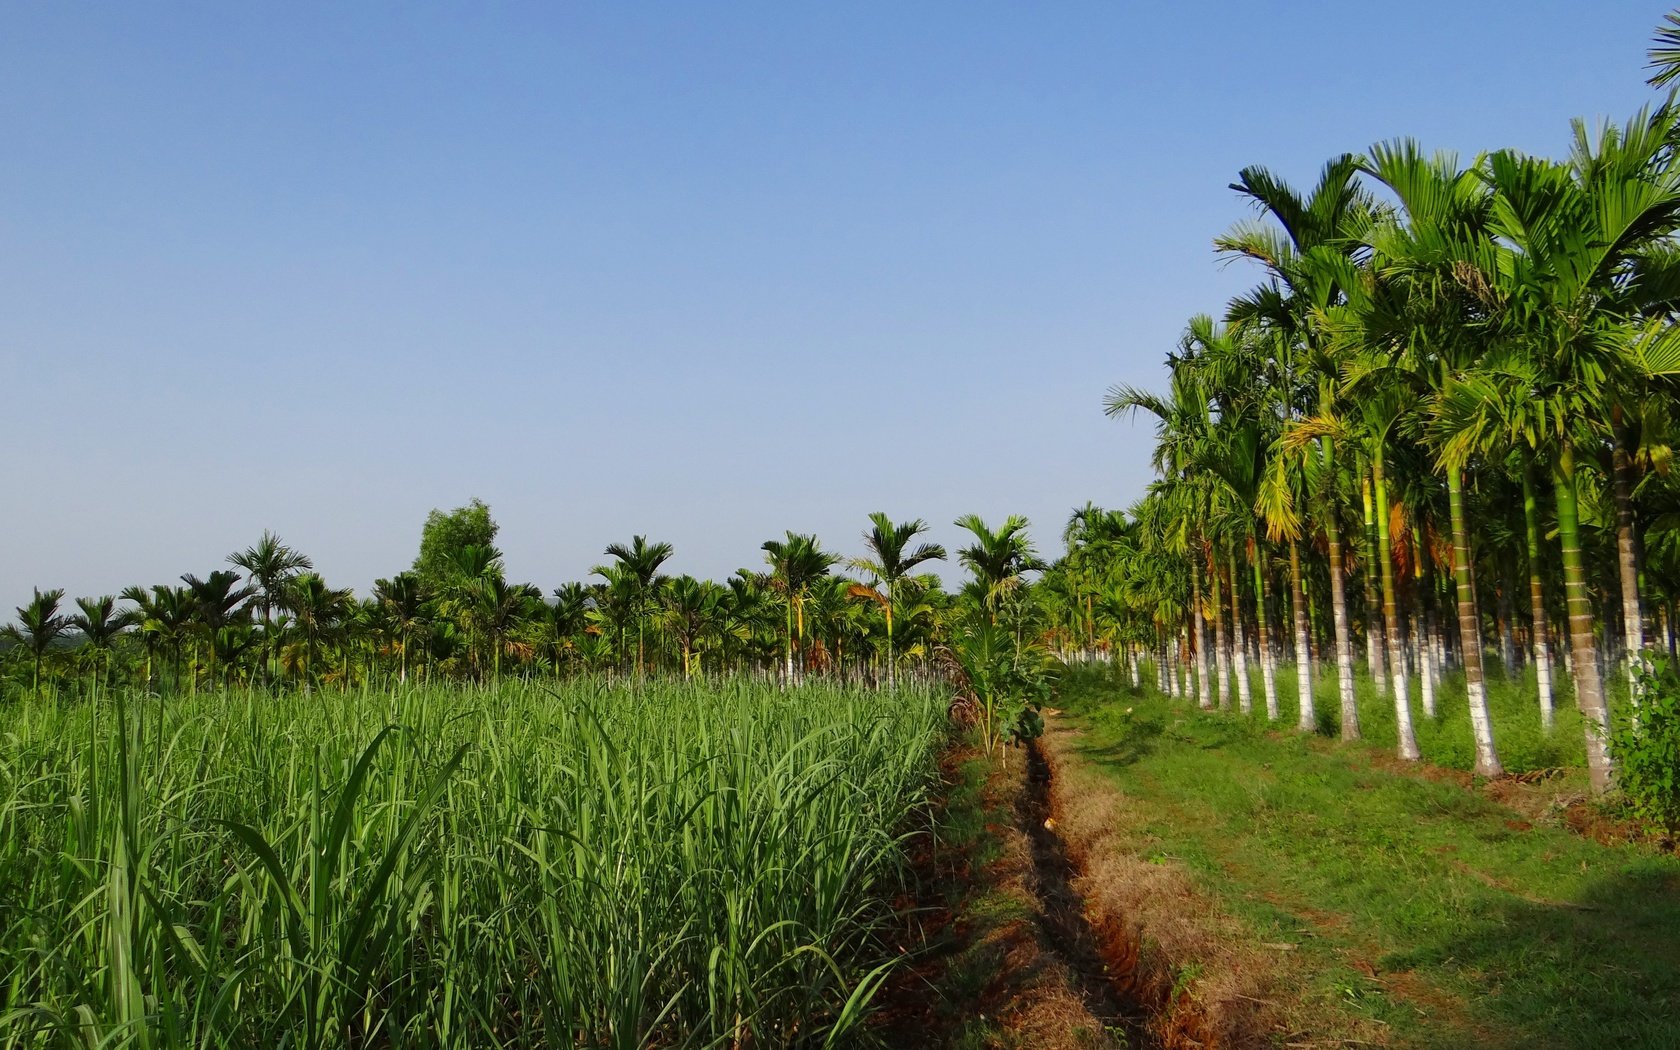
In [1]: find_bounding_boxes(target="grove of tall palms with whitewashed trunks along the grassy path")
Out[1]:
[1057,34,1680,791]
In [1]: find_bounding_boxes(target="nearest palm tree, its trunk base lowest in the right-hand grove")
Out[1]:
[1465,109,1680,791]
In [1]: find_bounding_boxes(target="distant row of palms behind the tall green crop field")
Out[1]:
[0,514,1042,692]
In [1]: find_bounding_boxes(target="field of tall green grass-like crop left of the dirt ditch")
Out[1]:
[0,682,942,1050]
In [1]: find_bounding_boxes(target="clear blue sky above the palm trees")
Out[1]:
[0,0,1665,601]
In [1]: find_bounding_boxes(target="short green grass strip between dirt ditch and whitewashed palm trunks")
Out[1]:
[1058,672,1680,1050]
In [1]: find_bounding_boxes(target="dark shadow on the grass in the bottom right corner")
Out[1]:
[1383,858,1680,1050]
